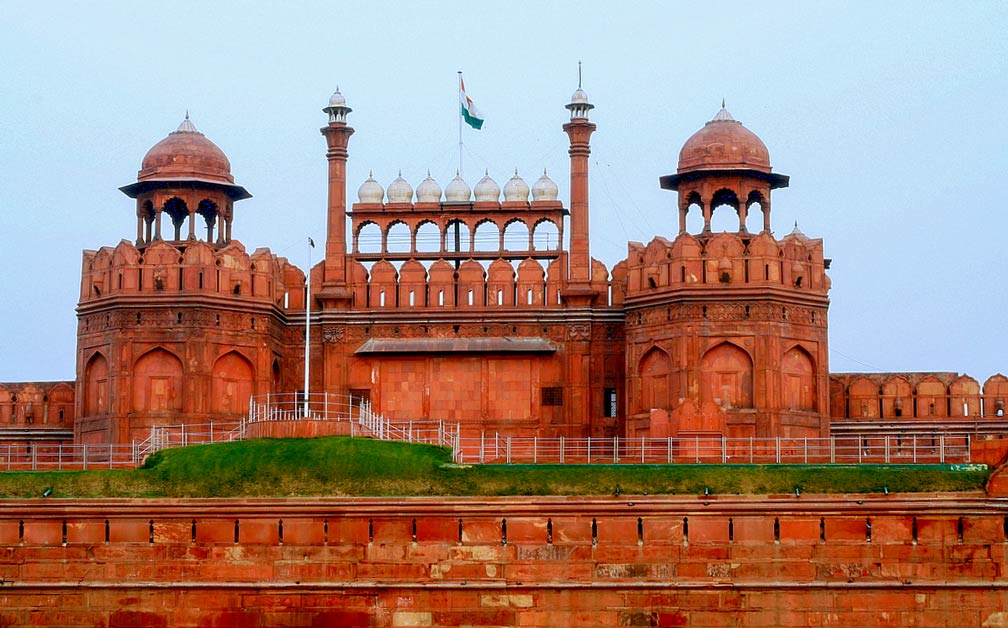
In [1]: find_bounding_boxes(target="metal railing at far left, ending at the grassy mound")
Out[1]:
[0,444,141,471]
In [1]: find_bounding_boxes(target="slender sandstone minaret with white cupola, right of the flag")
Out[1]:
[563,72,596,304]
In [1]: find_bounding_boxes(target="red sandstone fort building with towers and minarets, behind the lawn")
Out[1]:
[0,83,1008,444]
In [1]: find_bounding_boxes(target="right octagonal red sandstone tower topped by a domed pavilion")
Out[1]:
[625,104,830,437]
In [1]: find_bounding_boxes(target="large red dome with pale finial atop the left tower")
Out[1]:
[136,113,235,183]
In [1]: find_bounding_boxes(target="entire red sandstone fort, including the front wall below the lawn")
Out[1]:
[0,88,1008,628]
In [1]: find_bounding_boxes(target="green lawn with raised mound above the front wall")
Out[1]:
[0,436,990,498]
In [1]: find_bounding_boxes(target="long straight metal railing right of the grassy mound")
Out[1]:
[456,433,970,465]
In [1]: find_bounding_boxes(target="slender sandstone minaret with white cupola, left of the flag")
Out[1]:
[322,88,354,302]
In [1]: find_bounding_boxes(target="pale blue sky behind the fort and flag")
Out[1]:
[0,1,1008,381]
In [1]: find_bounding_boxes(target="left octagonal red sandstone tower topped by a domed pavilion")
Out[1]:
[74,114,303,444]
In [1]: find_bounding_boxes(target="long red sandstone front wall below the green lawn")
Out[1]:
[0,494,1008,628]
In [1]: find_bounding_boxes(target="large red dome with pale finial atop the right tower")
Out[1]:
[678,104,771,173]
